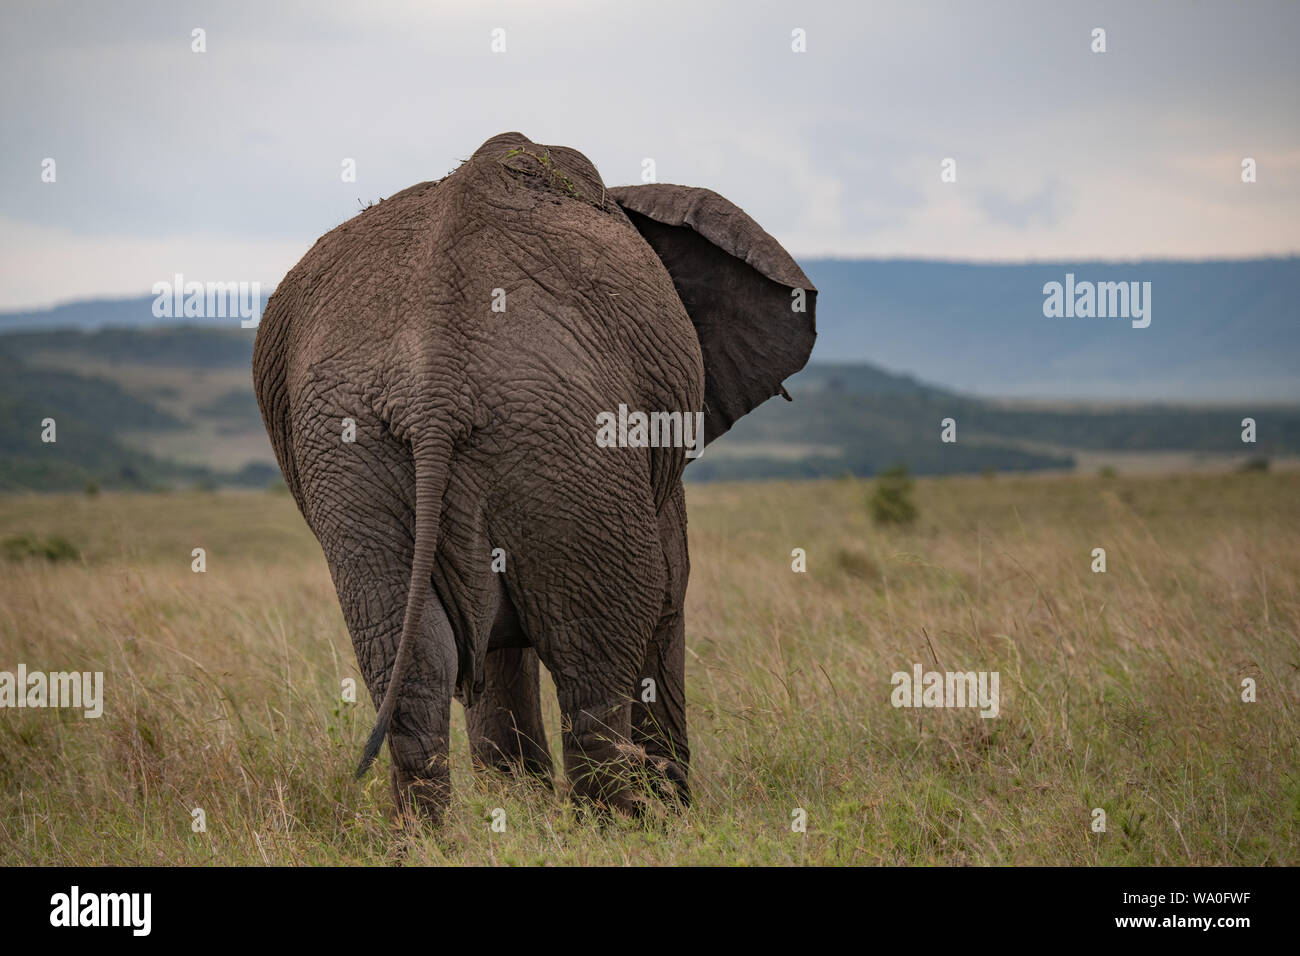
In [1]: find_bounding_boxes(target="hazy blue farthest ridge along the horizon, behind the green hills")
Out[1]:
[0,258,1300,402]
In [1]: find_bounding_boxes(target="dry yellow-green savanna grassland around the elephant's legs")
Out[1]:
[0,472,1300,865]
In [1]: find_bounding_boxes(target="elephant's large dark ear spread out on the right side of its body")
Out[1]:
[608,183,816,444]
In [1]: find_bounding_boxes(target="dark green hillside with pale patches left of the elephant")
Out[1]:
[0,326,270,490]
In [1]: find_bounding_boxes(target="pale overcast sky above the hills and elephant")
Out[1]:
[0,0,1300,308]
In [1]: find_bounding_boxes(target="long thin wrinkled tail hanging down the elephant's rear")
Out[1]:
[356,441,451,779]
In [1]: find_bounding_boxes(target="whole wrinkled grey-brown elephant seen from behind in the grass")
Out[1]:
[252,133,816,821]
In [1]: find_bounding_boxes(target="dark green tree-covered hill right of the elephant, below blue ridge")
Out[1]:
[702,364,1300,481]
